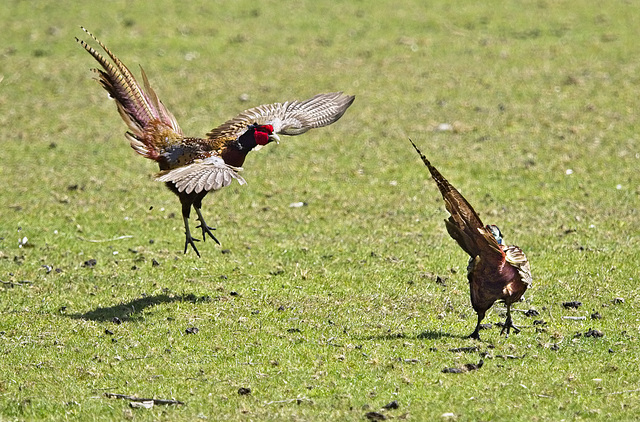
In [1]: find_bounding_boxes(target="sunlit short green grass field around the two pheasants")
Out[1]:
[0,0,640,421]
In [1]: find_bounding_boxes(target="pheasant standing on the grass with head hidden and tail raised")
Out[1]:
[409,140,532,340]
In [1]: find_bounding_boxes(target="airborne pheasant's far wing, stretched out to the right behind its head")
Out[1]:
[207,92,355,139]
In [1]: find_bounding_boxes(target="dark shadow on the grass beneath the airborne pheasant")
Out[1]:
[69,294,211,322]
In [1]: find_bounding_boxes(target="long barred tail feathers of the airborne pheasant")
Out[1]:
[76,28,182,159]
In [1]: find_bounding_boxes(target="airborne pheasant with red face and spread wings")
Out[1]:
[76,28,355,257]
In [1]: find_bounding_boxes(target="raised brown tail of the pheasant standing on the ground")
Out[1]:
[409,140,505,261]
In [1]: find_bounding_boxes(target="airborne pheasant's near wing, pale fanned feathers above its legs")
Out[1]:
[156,155,247,193]
